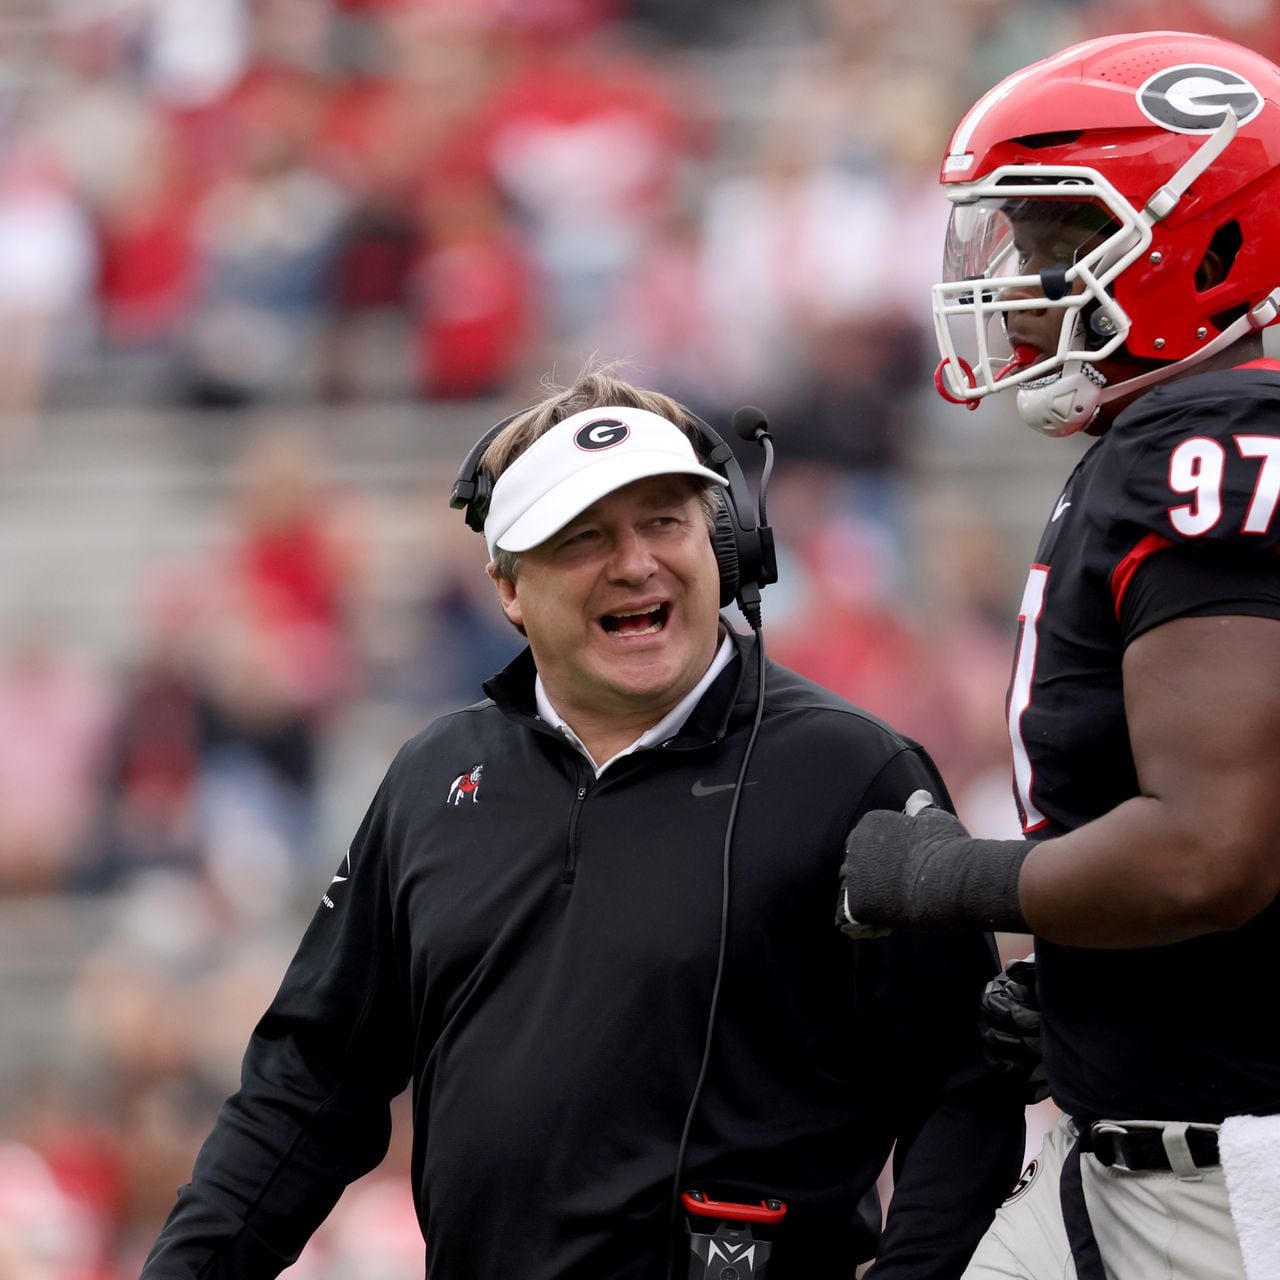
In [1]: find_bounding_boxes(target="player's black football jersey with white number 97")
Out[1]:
[1007,361,1280,1121]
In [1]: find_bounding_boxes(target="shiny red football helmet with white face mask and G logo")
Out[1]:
[933,31,1280,435]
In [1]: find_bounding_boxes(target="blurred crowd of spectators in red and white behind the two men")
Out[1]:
[0,0,1280,1280]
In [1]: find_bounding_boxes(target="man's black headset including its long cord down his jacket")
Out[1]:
[449,404,778,1280]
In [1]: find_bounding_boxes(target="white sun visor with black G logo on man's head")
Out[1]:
[484,404,728,559]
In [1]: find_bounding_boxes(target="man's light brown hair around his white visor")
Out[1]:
[480,365,721,582]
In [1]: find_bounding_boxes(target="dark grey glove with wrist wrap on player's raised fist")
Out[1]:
[836,791,1032,938]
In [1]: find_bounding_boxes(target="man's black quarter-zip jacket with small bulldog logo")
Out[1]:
[142,637,1023,1280]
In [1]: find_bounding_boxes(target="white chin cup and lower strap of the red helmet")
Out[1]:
[1018,285,1280,436]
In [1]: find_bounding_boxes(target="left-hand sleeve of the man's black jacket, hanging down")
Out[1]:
[142,768,411,1280]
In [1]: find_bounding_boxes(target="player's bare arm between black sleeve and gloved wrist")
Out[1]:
[1018,617,1280,947]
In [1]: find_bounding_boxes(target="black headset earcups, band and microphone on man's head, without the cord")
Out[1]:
[449,406,778,631]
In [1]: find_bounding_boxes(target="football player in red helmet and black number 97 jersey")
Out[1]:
[838,32,1280,1280]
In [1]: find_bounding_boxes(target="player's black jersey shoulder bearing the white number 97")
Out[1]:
[1105,369,1280,550]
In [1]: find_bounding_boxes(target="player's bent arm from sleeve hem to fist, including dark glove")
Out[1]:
[840,609,1280,947]
